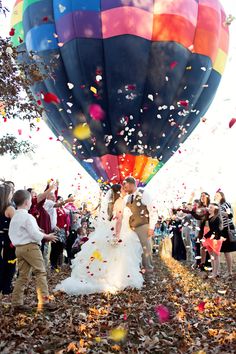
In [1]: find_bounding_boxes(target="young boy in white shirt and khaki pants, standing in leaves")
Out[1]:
[9,190,57,312]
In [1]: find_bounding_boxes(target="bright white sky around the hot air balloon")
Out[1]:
[0,0,236,210]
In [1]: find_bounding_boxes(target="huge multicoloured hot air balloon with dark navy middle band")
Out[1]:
[11,0,229,185]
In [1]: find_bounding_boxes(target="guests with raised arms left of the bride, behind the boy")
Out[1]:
[0,180,93,308]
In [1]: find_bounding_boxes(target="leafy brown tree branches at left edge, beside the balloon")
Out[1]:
[0,35,40,158]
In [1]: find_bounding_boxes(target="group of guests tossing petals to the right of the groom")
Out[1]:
[154,190,236,278]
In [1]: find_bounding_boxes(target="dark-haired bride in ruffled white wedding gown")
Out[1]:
[55,184,143,295]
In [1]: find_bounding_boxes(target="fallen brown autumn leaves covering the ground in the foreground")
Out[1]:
[0,256,236,354]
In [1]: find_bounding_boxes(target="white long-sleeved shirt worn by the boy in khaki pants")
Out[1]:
[9,209,44,246]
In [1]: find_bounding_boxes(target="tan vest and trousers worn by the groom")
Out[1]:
[126,190,154,271]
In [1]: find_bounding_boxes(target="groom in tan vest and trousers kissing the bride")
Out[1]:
[123,177,158,274]
